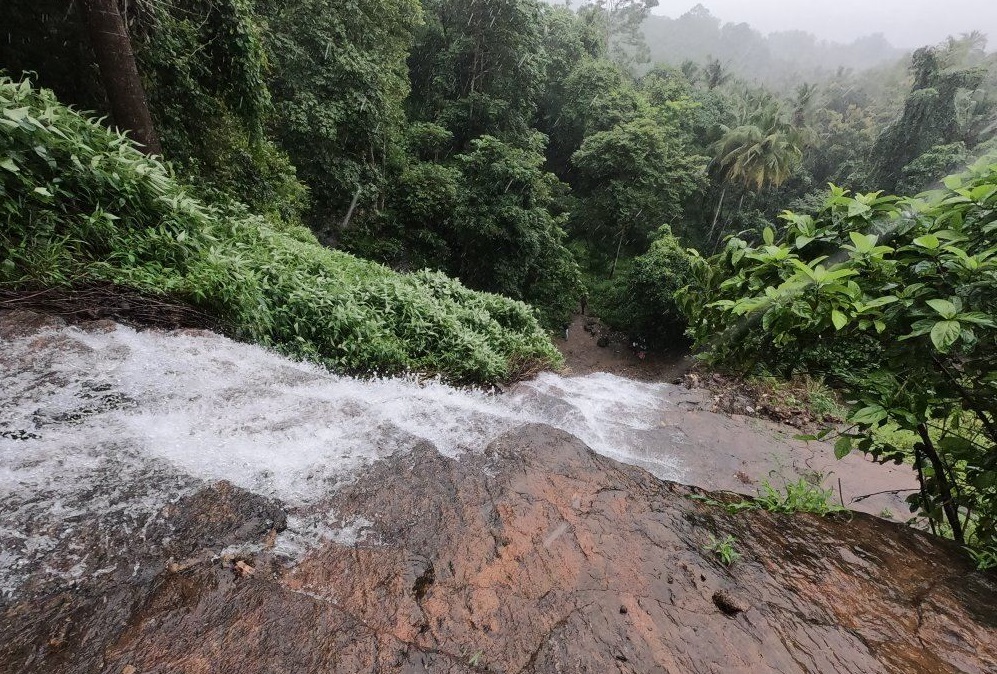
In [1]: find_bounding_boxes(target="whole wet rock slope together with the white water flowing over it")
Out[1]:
[0,313,997,674]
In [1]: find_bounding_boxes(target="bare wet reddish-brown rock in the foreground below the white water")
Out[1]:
[0,426,997,674]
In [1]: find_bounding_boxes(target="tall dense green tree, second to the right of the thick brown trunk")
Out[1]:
[255,0,420,242]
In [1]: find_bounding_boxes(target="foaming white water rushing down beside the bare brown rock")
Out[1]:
[0,320,682,592]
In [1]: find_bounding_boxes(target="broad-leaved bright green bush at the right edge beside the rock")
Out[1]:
[679,165,997,546]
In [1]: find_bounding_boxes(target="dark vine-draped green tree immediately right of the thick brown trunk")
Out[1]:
[135,0,305,215]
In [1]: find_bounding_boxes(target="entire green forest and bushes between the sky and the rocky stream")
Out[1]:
[0,0,997,556]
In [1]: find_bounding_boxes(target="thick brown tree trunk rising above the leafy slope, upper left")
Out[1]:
[79,0,162,154]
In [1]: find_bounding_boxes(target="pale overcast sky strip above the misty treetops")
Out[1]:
[655,0,997,51]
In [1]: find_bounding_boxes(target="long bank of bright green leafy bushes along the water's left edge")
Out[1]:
[0,78,560,382]
